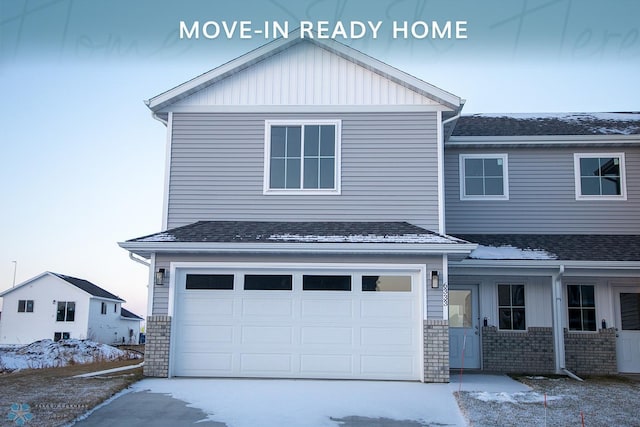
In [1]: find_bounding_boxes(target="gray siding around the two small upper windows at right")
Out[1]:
[445,146,640,234]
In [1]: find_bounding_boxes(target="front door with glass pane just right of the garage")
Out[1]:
[449,285,480,369]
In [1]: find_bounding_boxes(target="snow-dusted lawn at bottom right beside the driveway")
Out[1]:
[456,376,640,427]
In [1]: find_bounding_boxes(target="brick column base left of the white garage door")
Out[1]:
[144,316,171,378]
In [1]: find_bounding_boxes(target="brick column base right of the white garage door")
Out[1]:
[424,320,449,383]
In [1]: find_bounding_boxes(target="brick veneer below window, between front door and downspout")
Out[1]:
[482,326,555,374]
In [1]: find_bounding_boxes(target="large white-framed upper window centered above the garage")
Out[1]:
[264,120,340,194]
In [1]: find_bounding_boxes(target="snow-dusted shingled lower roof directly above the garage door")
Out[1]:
[120,221,475,256]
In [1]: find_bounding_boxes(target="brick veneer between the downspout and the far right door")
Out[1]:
[564,328,618,375]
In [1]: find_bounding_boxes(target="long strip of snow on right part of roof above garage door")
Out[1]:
[268,233,454,243]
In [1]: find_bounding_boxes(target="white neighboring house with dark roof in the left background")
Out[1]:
[0,272,143,344]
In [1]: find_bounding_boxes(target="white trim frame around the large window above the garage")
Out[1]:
[262,119,342,196]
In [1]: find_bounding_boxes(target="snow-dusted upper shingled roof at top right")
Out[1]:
[452,112,640,138]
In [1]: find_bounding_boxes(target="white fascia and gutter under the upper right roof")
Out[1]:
[445,135,640,147]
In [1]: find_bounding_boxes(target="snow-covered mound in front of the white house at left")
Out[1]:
[0,339,140,372]
